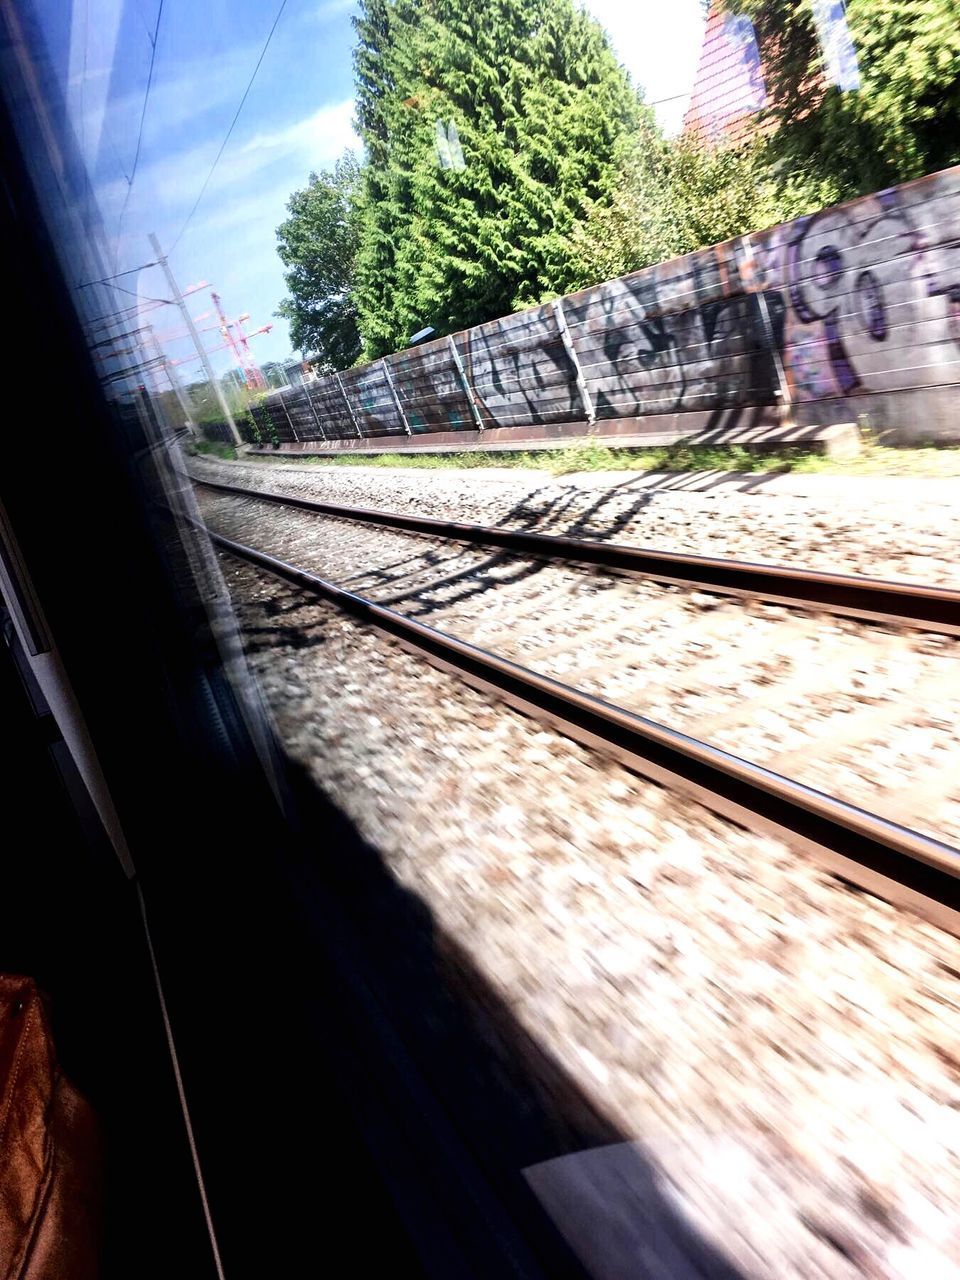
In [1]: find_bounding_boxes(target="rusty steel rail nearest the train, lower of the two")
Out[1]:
[210,531,960,933]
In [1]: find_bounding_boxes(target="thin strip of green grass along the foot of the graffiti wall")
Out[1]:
[245,439,960,477]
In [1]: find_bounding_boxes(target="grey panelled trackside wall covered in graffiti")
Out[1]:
[261,169,960,439]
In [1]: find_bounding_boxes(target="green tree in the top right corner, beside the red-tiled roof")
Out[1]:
[728,0,960,198]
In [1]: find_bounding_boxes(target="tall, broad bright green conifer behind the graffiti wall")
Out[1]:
[355,0,649,356]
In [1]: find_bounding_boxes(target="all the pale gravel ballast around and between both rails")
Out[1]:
[191,460,960,1280]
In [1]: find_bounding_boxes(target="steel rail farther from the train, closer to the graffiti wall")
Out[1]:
[192,476,960,635]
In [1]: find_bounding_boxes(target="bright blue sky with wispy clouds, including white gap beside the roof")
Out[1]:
[52,0,704,381]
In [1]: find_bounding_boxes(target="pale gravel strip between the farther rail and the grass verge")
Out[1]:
[189,458,960,585]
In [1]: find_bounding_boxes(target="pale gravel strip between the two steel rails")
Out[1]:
[200,490,960,845]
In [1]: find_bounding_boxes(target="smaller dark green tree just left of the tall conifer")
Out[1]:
[276,151,360,371]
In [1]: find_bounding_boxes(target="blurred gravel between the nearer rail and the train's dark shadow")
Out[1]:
[223,558,960,1280]
